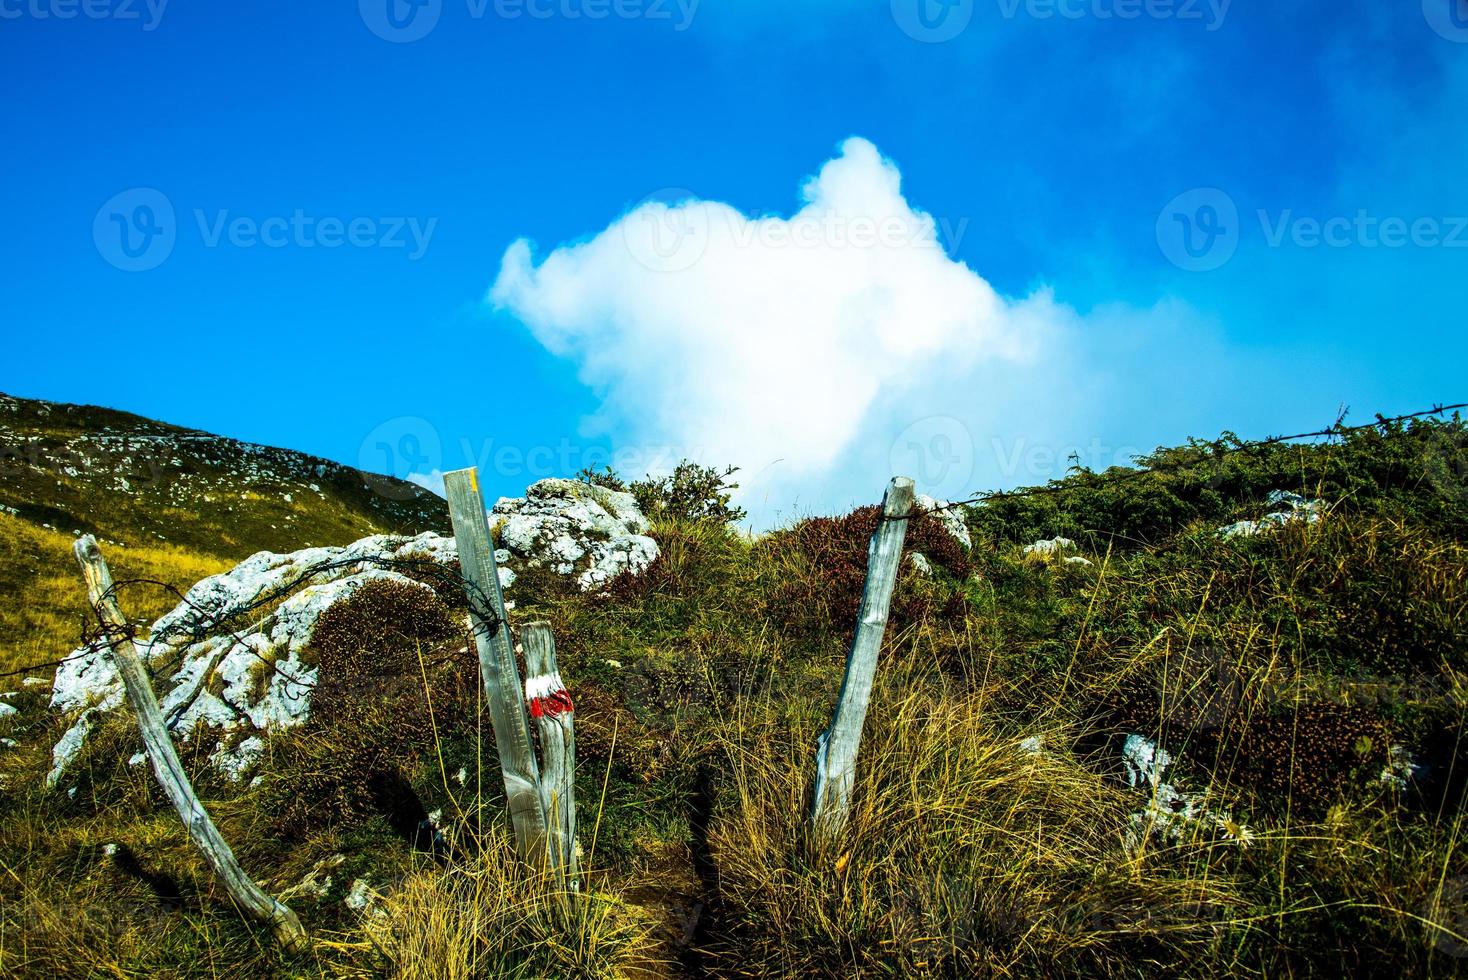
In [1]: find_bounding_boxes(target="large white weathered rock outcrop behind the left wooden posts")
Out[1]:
[48,480,658,785]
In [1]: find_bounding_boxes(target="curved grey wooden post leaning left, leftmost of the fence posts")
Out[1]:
[75,534,310,952]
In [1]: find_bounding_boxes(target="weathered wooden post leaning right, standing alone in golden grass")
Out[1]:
[810,477,915,839]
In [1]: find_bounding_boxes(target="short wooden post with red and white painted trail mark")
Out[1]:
[520,622,580,891]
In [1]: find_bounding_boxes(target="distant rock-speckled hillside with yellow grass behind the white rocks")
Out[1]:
[0,395,448,670]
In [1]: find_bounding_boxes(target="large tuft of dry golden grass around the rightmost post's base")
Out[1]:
[711,636,1239,977]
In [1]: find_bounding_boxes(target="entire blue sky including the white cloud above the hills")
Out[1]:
[0,0,1468,522]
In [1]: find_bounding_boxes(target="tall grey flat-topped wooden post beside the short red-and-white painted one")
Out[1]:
[443,467,546,867]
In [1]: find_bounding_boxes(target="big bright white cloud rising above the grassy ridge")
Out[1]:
[489,138,1215,524]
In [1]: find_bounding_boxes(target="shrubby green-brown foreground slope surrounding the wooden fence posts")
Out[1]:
[0,407,1468,979]
